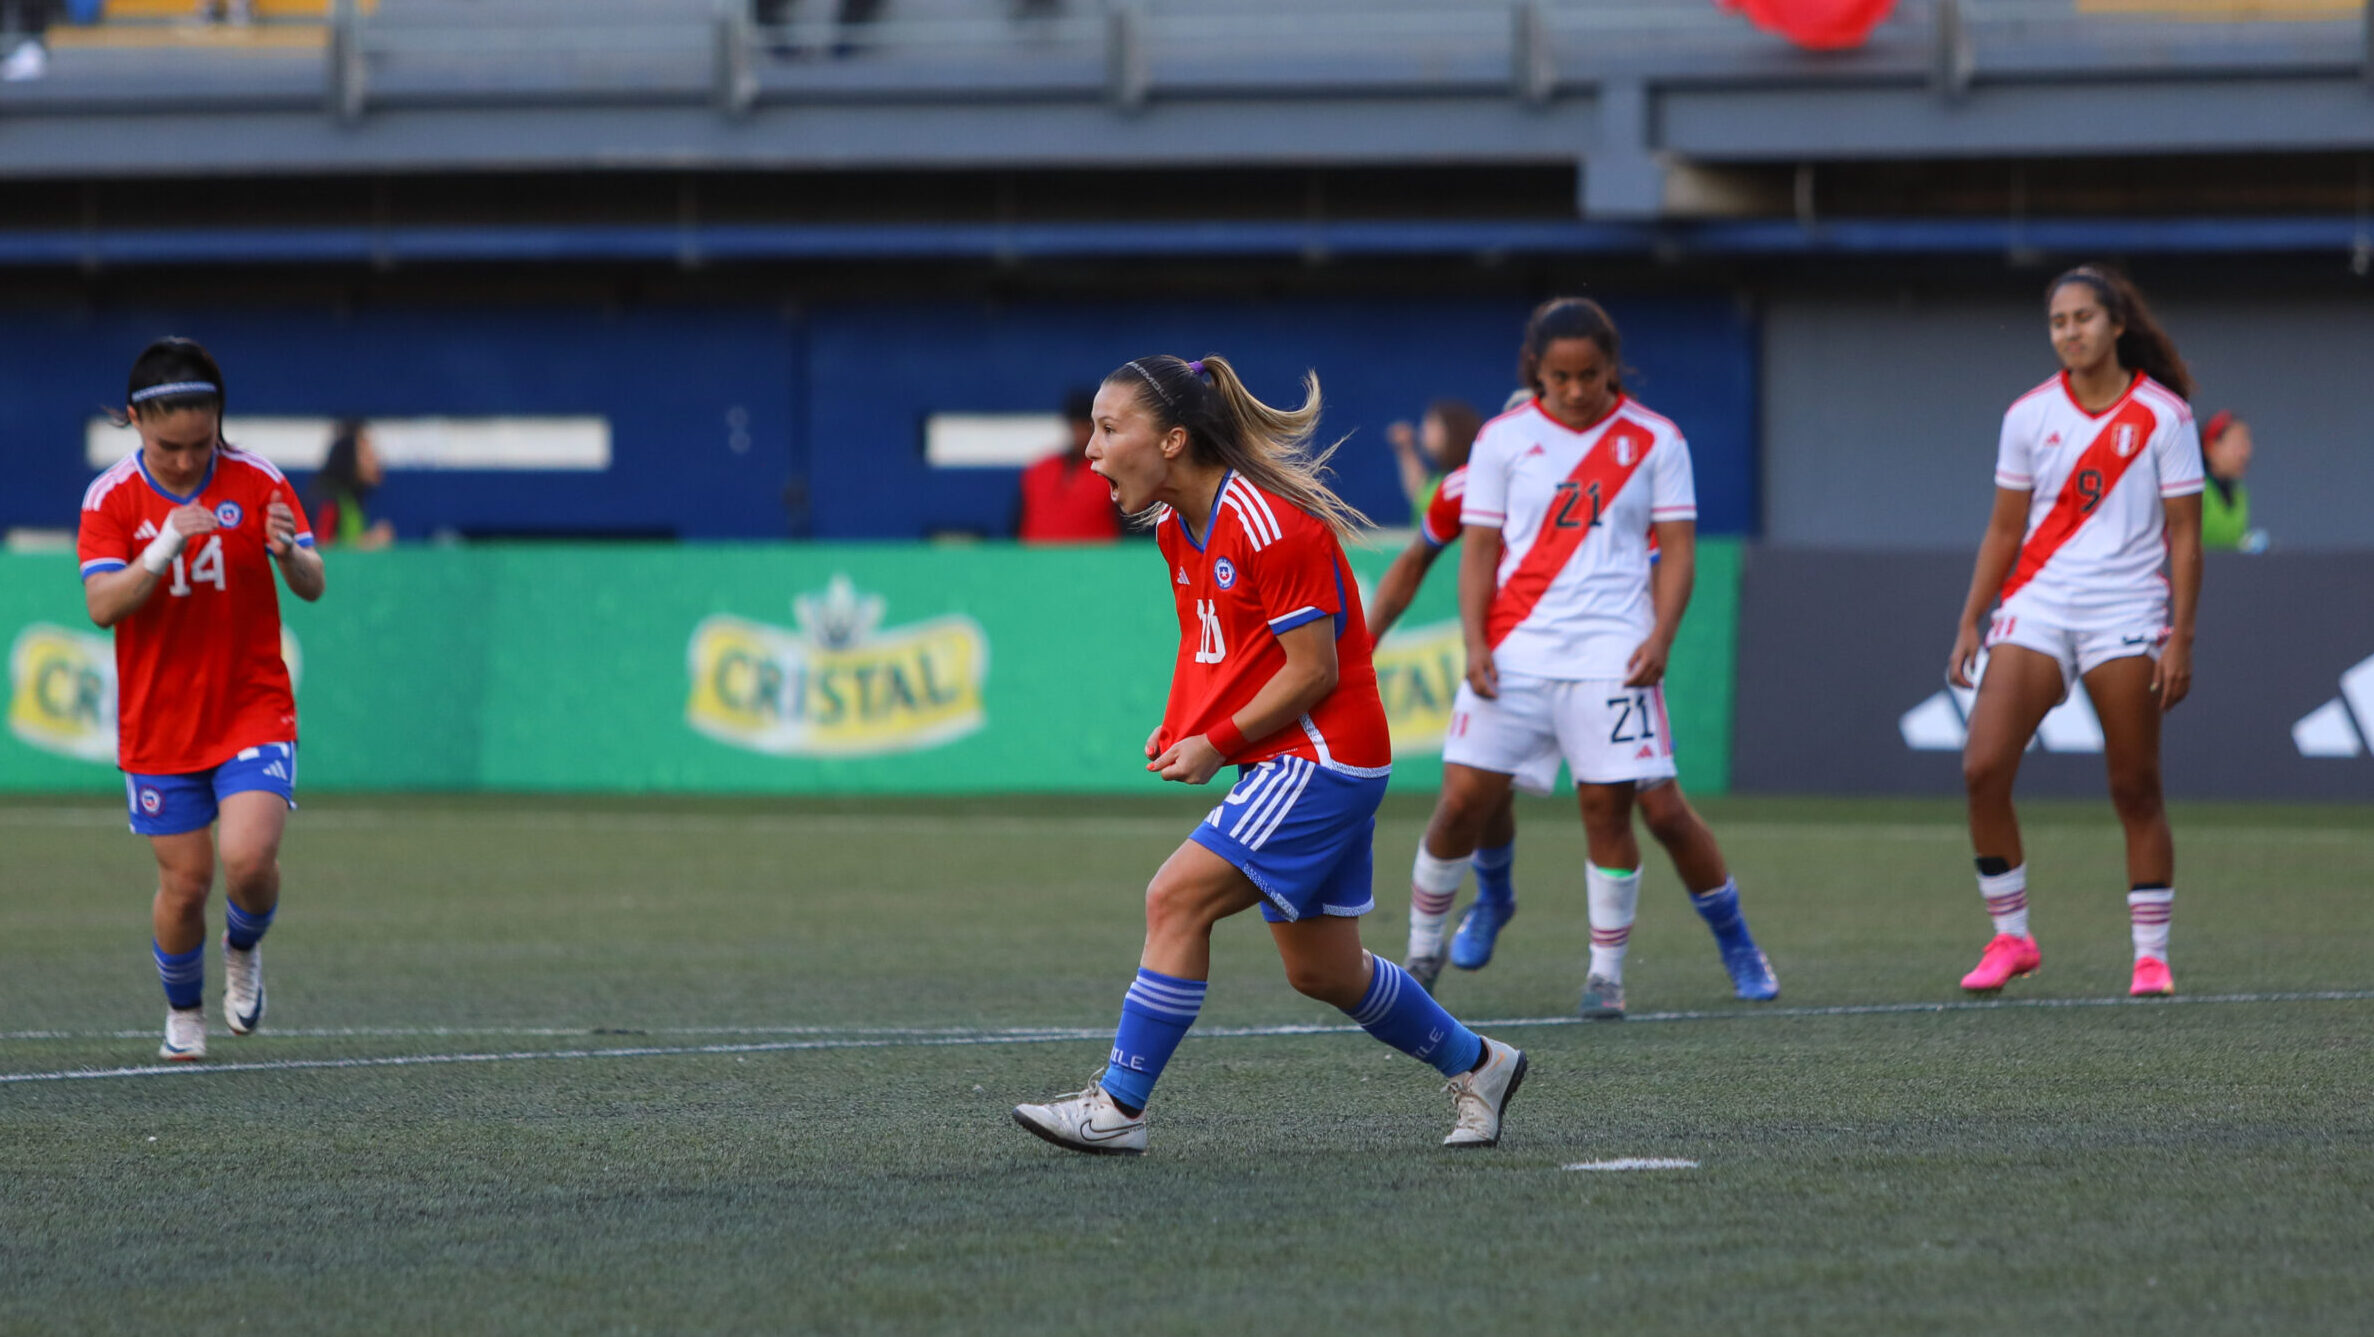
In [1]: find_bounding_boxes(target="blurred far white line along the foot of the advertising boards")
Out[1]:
[0,807,2369,845]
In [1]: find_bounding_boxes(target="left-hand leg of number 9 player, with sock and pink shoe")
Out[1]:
[1961,646,2061,993]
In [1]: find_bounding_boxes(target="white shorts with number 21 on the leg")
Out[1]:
[1443,674,1674,793]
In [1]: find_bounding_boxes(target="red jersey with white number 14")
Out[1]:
[78,446,313,774]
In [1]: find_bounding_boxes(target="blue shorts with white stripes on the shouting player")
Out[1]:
[1189,755,1386,924]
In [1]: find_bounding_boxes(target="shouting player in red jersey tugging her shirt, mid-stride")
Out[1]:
[1014,356,1524,1154]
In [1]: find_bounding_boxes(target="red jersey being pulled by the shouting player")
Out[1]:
[1156,473,1394,774]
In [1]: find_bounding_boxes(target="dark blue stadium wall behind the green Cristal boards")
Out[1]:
[0,297,1759,539]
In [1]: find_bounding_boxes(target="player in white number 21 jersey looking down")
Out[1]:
[1410,297,1781,1019]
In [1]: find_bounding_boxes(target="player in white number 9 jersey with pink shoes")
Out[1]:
[1947,264,2203,997]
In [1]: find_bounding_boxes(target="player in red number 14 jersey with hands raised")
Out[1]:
[78,340,323,1059]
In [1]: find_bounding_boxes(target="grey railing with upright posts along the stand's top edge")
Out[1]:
[13,0,2374,116]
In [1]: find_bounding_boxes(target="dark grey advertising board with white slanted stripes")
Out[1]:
[1731,549,2374,798]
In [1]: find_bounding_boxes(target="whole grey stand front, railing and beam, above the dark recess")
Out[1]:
[0,0,2374,218]
